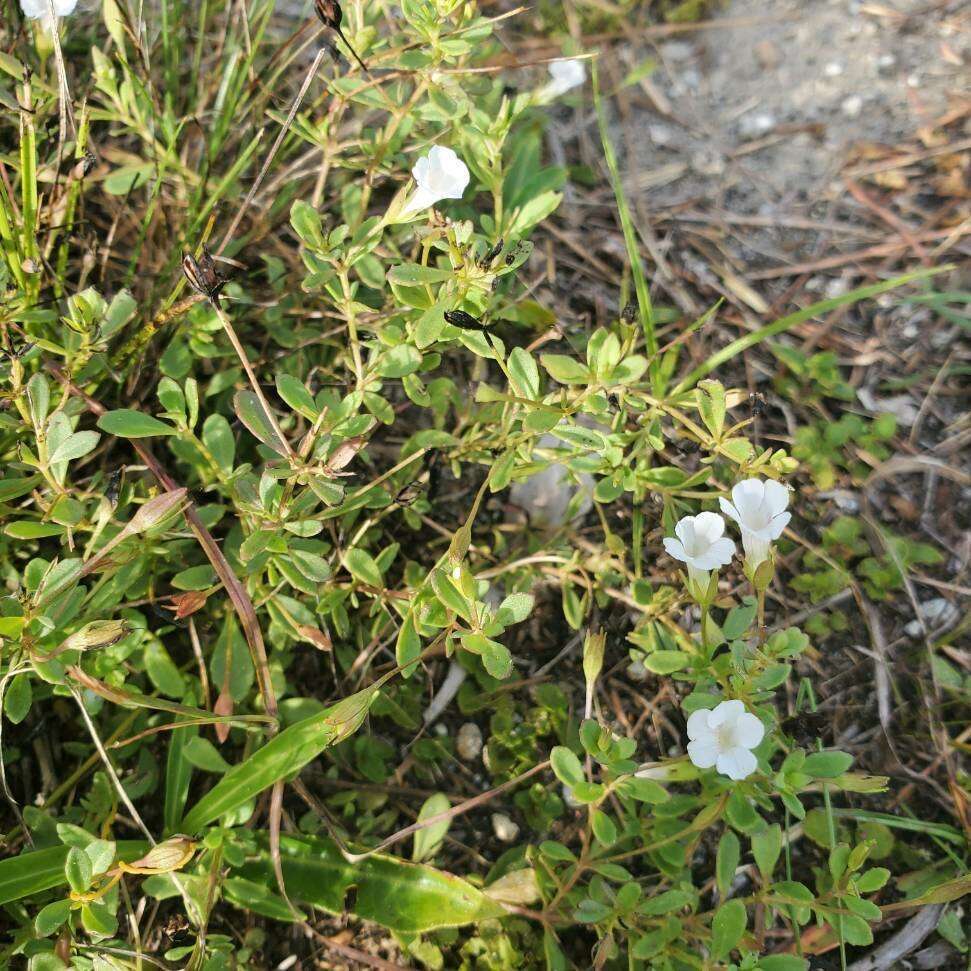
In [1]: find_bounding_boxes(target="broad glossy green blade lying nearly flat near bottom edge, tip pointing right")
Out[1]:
[224,835,506,934]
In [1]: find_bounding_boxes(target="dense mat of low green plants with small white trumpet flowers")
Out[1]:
[0,0,971,971]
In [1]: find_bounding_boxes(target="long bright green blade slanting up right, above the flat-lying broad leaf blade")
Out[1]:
[182,687,378,834]
